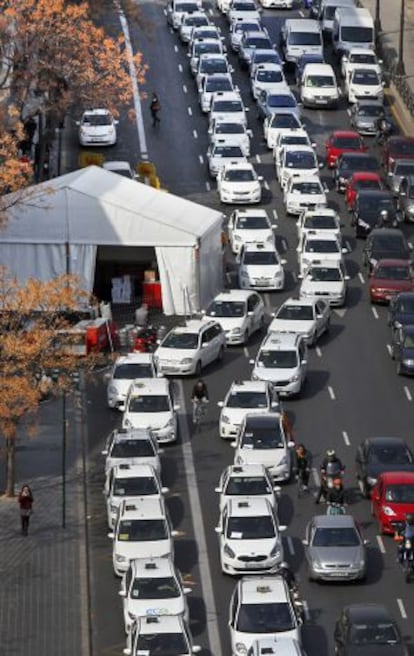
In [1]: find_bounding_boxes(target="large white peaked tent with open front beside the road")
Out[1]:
[0,166,223,314]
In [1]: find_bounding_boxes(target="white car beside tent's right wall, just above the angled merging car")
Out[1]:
[238,242,286,291]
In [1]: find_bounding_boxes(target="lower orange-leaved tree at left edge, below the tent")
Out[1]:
[0,267,102,496]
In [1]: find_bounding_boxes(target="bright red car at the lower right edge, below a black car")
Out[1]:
[371,472,414,534]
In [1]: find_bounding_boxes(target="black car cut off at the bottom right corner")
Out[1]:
[334,604,408,656]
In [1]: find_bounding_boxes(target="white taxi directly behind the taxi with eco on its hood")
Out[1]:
[108,497,177,576]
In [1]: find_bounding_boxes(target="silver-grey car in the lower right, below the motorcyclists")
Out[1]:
[303,515,367,581]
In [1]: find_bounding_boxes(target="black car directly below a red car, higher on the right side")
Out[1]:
[351,189,399,238]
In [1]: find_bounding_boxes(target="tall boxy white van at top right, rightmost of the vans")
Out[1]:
[332,8,375,57]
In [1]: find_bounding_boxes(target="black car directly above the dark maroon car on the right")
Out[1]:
[362,228,411,272]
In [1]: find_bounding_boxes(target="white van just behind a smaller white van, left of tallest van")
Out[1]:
[281,18,323,64]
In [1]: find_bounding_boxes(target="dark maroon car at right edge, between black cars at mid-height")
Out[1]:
[369,260,414,303]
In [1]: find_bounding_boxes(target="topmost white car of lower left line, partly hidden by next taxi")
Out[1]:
[105,353,157,410]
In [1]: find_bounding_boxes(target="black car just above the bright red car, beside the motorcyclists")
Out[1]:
[355,437,414,497]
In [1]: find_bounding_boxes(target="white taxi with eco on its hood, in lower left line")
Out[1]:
[119,556,191,633]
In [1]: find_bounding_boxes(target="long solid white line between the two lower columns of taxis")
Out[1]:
[177,381,223,654]
